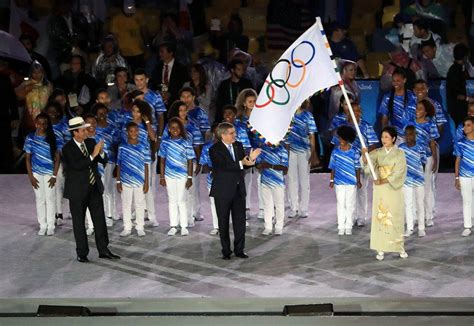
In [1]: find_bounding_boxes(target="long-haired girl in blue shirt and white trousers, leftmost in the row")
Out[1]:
[23,113,59,235]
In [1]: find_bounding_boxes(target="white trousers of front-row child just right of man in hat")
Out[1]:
[122,185,145,231]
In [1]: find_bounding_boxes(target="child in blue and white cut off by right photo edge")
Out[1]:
[454,116,474,237]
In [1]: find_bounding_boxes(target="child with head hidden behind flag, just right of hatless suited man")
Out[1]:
[257,144,288,235]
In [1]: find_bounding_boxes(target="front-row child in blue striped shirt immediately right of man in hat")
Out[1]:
[116,122,151,237]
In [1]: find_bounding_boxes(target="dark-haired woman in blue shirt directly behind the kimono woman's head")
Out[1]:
[378,68,417,144]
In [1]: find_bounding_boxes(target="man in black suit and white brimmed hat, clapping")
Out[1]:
[62,117,120,263]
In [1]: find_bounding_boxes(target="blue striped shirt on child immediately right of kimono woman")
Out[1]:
[398,143,426,187]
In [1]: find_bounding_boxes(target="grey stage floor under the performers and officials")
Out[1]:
[0,174,474,304]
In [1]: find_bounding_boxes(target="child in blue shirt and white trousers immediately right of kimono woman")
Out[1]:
[399,125,426,237]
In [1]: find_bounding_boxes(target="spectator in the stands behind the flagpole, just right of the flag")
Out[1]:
[328,60,360,121]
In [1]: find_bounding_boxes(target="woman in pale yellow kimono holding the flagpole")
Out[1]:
[362,127,408,260]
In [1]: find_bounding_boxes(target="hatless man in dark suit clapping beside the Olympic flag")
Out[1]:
[209,122,260,260]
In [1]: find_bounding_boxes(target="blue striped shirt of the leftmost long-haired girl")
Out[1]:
[23,132,54,175]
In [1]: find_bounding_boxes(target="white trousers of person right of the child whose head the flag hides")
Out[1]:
[287,151,311,213]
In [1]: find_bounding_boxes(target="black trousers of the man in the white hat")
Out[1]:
[69,185,109,257]
